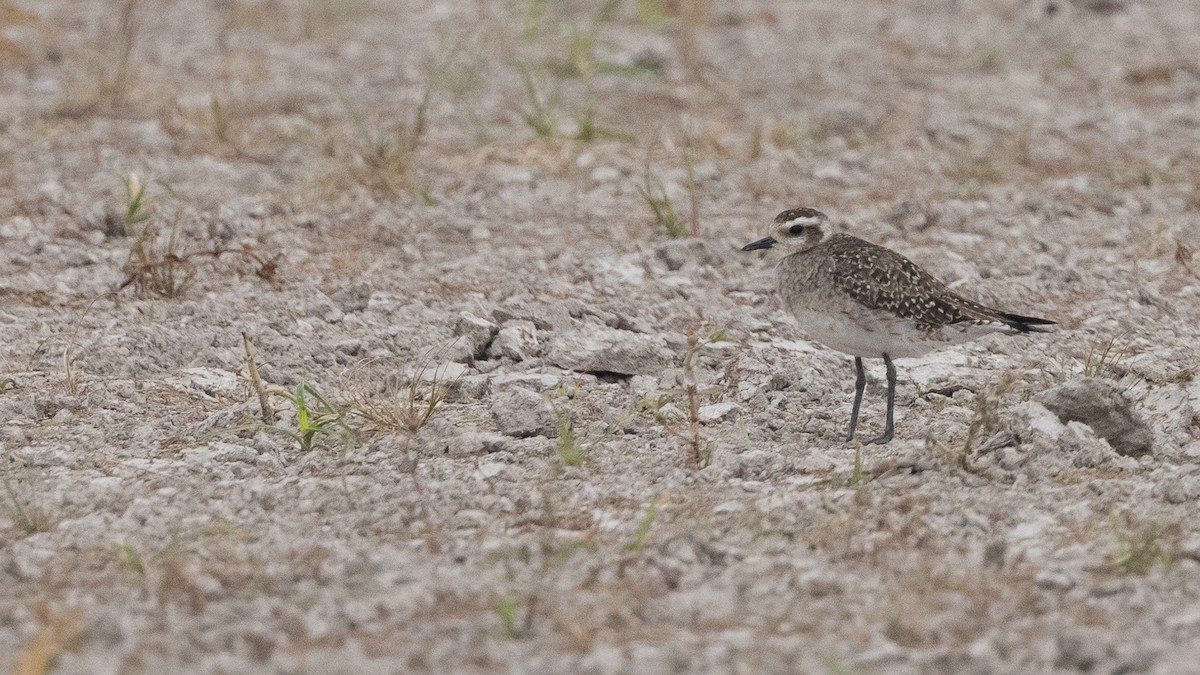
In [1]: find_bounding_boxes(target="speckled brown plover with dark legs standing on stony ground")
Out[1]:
[742,208,1056,446]
